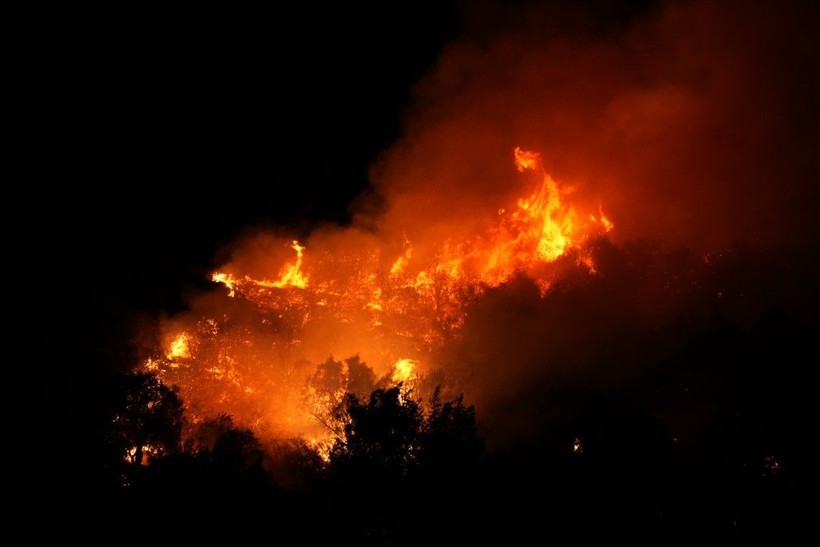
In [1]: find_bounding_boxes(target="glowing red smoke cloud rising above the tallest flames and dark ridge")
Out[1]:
[372,2,820,250]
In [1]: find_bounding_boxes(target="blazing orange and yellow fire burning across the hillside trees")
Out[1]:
[144,148,613,441]
